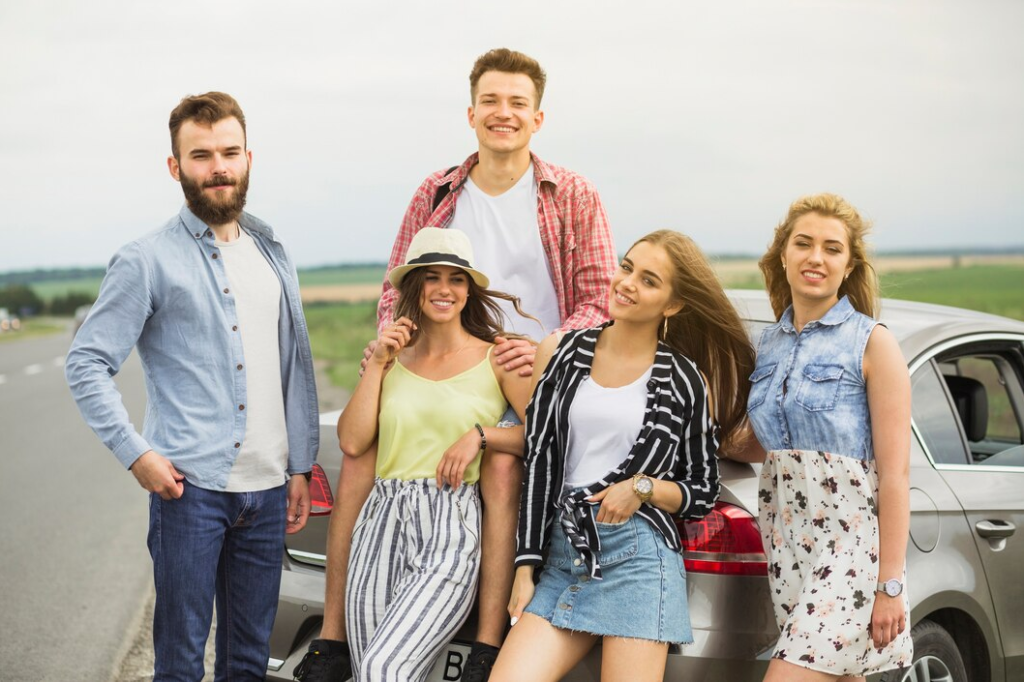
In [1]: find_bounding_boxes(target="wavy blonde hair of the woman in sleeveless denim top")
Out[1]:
[758,193,881,319]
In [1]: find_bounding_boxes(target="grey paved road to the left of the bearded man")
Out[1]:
[0,327,152,682]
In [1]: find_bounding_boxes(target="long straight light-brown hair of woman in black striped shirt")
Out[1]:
[630,229,754,443]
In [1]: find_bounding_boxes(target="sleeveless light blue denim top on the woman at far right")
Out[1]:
[746,296,878,460]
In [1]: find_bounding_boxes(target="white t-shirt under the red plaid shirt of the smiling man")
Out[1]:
[451,164,561,341]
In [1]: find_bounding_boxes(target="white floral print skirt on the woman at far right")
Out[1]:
[760,450,913,675]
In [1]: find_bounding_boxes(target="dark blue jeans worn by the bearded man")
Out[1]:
[148,482,288,682]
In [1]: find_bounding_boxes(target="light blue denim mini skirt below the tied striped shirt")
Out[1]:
[526,514,693,644]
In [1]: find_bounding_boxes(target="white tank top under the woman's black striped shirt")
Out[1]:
[565,368,652,488]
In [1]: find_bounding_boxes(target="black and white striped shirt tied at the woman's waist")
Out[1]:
[515,323,719,579]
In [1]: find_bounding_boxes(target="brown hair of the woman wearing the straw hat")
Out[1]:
[394,267,540,343]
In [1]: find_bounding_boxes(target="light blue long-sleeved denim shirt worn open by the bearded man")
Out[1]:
[65,206,319,491]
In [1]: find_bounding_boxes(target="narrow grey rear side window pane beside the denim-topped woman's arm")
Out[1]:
[910,363,968,464]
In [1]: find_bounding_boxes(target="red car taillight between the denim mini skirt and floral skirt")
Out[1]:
[678,502,768,576]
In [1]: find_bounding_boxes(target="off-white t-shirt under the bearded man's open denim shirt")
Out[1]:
[217,230,288,493]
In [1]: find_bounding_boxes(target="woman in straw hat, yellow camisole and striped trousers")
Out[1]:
[338,227,529,682]
